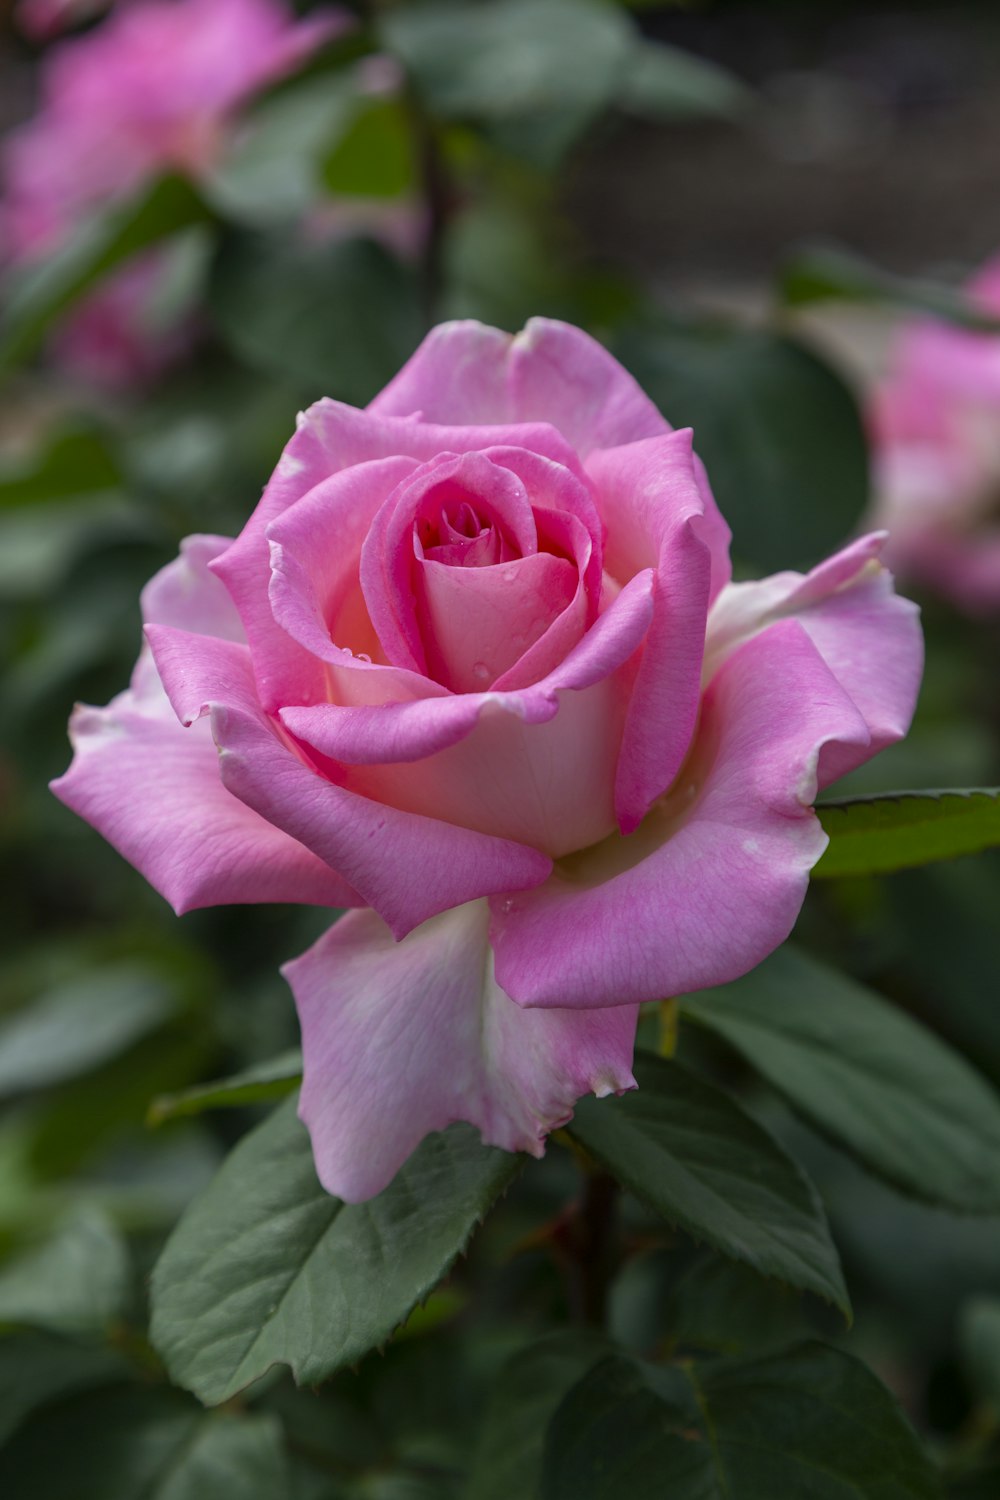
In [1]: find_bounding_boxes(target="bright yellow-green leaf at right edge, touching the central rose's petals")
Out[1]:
[813,786,1000,879]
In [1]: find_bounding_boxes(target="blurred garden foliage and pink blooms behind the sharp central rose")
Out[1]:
[0,0,1000,1500]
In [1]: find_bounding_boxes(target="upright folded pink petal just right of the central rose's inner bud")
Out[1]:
[588,429,712,833]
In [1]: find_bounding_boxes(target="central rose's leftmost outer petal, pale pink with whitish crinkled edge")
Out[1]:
[51,650,360,915]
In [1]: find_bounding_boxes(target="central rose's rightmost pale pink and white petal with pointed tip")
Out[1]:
[705,533,924,788]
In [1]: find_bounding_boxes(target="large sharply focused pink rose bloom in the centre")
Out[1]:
[54,320,921,1200]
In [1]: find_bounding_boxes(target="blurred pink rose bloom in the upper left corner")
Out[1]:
[0,0,344,386]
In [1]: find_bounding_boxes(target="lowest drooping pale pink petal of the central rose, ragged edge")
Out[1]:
[282,902,639,1203]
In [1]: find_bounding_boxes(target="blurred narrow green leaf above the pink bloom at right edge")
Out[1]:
[778,246,1000,333]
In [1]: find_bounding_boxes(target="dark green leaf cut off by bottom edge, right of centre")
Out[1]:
[541,1344,940,1500]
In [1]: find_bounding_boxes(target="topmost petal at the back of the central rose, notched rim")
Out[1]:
[369,318,670,456]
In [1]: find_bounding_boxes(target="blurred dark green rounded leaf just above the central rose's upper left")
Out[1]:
[210,234,421,405]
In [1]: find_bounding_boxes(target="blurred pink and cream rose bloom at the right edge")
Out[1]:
[870,260,1000,615]
